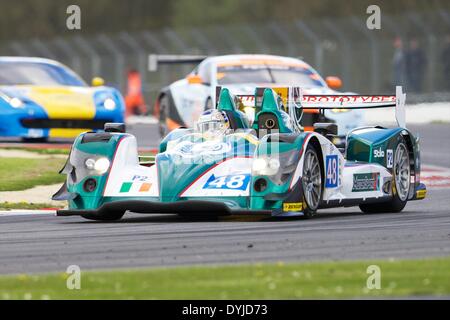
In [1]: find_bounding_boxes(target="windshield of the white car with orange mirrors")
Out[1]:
[217,65,325,87]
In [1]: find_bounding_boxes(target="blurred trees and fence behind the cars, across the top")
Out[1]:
[0,0,450,112]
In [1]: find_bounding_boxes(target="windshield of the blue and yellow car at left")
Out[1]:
[0,62,86,87]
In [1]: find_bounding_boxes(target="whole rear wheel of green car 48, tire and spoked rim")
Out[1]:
[359,138,411,213]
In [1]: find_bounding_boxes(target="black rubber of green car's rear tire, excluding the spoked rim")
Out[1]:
[359,139,410,213]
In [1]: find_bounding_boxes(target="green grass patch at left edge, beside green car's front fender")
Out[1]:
[0,158,66,191]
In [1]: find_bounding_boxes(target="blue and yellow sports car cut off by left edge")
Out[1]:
[0,57,125,140]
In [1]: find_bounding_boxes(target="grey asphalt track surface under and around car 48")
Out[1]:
[0,124,450,274]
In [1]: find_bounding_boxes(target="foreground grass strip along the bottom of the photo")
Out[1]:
[0,258,450,299]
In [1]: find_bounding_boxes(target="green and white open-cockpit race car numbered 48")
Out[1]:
[53,88,426,220]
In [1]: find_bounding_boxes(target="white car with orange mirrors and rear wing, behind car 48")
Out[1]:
[153,54,364,136]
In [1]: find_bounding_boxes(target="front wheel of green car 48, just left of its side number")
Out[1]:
[302,144,323,219]
